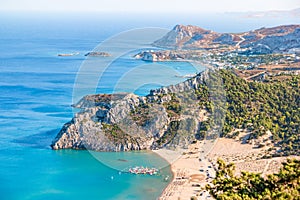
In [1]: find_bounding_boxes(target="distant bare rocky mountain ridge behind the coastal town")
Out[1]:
[153,25,300,53]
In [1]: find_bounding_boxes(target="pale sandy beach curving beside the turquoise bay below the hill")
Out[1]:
[154,138,300,200]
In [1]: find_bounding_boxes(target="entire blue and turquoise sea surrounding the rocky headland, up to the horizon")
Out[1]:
[0,12,299,200]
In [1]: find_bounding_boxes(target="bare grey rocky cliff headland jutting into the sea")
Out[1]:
[51,72,207,151]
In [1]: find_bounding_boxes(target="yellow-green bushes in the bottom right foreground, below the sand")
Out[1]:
[206,159,300,200]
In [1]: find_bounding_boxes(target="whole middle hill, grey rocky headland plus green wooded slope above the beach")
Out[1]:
[52,70,300,156]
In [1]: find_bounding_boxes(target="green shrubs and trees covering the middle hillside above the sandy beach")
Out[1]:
[131,69,300,156]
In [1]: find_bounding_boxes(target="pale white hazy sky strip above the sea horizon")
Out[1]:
[0,0,300,12]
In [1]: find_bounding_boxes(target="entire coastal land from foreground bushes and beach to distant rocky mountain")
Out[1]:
[51,25,300,199]
